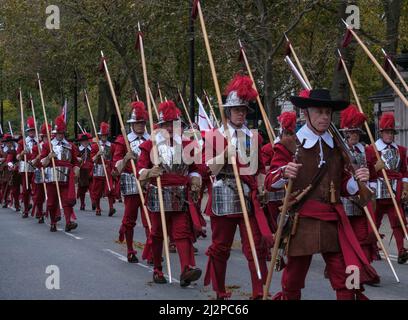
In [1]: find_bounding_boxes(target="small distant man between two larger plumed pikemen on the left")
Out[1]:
[77,133,93,210]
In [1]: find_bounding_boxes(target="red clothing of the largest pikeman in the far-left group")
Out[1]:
[41,142,79,224]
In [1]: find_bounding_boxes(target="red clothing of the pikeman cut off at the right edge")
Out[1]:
[366,146,408,254]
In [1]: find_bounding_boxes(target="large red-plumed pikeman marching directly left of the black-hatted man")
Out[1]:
[204,75,272,299]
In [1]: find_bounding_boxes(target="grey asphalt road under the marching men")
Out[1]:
[0,192,408,300]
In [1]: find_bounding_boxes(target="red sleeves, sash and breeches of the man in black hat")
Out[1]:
[265,143,378,299]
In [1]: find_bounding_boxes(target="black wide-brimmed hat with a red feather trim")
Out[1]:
[290,89,350,111]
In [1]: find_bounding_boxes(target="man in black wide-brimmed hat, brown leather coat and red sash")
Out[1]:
[265,89,378,300]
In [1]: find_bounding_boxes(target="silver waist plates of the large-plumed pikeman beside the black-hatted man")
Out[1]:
[211,177,252,216]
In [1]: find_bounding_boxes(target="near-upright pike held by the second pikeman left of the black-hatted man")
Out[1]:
[137,23,172,283]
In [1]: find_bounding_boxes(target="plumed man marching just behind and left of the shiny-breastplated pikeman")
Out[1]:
[113,101,150,263]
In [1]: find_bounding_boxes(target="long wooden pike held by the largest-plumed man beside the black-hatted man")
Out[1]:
[194,0,262,280]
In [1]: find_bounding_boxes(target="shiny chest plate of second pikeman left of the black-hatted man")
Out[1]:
[157,144,188,176]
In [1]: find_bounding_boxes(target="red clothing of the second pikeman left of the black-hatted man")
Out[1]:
[137,140,206,272]
